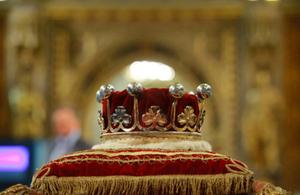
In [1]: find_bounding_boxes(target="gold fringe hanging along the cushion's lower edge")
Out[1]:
[31,173,253,195]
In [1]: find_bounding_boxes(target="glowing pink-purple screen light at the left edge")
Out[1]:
[0,146,29,172]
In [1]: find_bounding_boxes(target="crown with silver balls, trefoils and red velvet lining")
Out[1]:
[96,82,212,144]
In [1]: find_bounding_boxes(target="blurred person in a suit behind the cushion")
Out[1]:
[47,107,92,161]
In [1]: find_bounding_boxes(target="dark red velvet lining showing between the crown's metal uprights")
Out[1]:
[103,88,199,131]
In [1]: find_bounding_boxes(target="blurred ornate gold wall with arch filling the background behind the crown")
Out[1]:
[0,0,300,192]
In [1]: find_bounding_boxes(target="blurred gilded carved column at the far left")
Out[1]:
[7,5,46,139]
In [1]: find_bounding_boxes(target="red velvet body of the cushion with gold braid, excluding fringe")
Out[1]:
[35,149,246,178]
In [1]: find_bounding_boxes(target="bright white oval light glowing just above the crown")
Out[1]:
[130,61,175,81]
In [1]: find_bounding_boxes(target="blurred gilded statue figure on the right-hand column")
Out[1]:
[242,70,283,174]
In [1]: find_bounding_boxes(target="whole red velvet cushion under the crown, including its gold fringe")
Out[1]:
[31,149,253,195]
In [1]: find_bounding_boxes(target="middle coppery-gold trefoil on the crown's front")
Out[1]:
[142,106,167,128]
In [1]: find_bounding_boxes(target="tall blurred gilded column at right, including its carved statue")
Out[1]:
[241,4,284,181]
